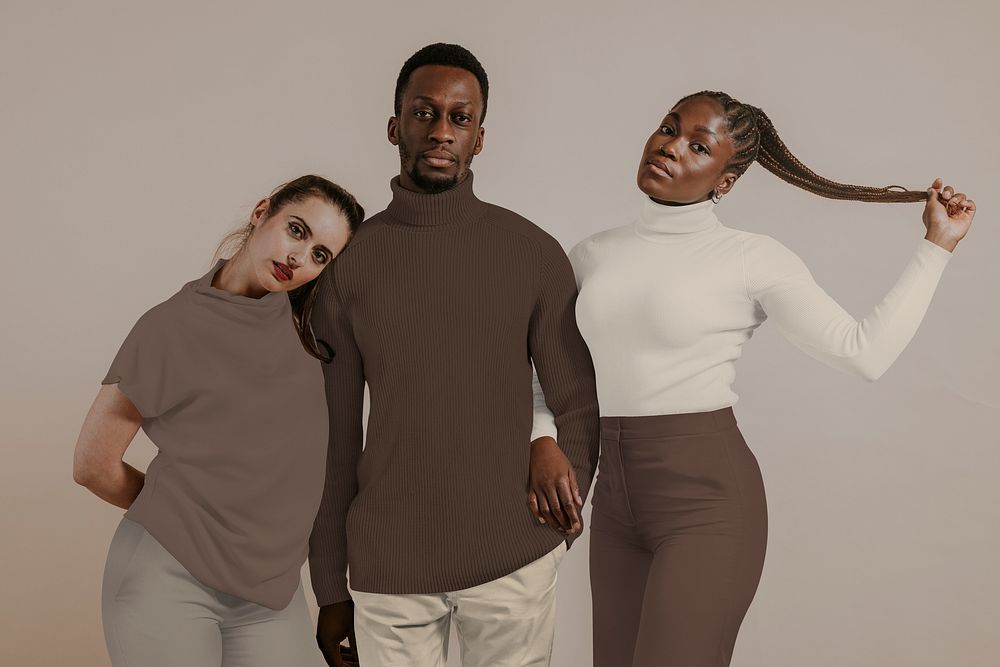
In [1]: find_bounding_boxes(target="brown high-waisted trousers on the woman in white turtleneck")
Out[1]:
[590,408,767,667]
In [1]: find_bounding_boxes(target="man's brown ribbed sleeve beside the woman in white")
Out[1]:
[528,238,600,516]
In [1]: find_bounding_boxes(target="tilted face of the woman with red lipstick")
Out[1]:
[244,197,351,292]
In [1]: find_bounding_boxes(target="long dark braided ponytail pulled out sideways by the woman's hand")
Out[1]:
[674,90,927,203]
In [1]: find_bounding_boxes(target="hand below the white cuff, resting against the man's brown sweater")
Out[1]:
[528,436,583,535]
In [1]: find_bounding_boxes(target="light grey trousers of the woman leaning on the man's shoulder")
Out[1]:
[101,518,326,667]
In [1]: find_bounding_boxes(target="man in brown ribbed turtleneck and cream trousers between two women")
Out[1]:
[309,44,600,666]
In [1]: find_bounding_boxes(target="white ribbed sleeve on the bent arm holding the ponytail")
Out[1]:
[743,236,951,381]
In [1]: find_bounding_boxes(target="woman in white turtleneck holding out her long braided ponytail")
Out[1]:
[529,91,975,667]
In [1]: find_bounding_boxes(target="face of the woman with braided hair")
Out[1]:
[636,97,736,205]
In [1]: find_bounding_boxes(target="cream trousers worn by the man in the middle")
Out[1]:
[351,542,566,667]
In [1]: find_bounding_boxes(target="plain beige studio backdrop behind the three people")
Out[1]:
[0,0,1000,667]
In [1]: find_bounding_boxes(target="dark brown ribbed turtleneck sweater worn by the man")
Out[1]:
[309,173,600,605]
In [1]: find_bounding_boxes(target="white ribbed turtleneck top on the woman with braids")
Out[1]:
[532,197,951,438]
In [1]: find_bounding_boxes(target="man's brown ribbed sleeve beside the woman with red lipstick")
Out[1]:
[309,266,365,606]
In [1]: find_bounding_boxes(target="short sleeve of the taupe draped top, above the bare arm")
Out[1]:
[101,313,177,419]
